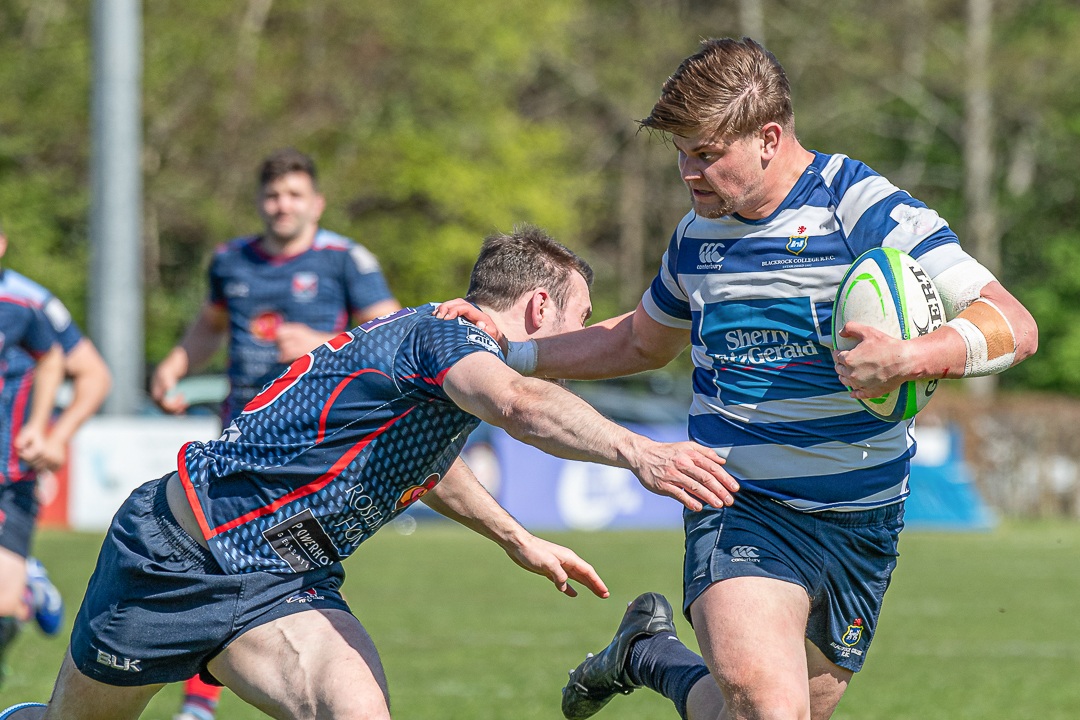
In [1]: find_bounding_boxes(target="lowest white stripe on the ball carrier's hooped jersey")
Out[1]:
[714,422,913,481]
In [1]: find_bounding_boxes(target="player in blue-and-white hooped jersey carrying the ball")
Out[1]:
[438,38,1038,720]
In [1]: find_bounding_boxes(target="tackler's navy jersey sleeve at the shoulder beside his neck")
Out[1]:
[407,308,505,394]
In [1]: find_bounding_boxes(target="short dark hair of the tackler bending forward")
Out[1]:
[465,225,593,313]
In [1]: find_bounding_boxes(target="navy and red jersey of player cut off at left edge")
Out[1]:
[0,270,61,483]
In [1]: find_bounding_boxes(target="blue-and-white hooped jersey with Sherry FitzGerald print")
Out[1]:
[642,153,970,512]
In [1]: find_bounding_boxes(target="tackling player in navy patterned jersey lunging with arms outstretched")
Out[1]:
[0,228,738,720]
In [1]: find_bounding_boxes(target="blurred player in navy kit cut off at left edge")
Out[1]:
[0,225,64,680]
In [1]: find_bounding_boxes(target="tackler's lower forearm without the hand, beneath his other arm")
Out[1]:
[421,458,529,549]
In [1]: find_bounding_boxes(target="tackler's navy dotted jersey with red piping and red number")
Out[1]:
[178,303,502,573]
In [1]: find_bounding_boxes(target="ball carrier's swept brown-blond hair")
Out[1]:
[639,38,795,138]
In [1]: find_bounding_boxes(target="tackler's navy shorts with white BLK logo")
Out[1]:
[71,475,349,687]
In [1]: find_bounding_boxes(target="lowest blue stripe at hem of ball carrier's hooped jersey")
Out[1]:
[735,455,914,510]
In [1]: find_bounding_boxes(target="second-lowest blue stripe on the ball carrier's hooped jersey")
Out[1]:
[690,410,893,448]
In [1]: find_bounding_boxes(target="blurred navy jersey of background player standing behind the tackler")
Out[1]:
[210,229,393,424]
